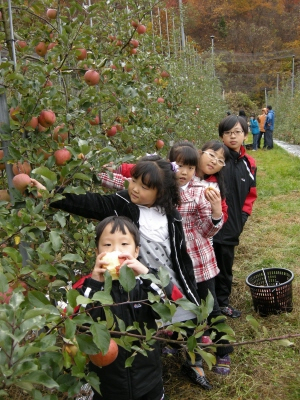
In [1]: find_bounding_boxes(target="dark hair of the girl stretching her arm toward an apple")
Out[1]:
[131,155,180,214]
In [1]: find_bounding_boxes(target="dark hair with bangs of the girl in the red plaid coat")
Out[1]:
[169,140,199,174]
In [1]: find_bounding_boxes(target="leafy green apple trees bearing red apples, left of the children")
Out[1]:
[0,0,230,400]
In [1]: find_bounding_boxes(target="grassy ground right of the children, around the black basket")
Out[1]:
[164,146,300,400]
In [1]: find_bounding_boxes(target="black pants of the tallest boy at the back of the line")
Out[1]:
[214,243,235,307]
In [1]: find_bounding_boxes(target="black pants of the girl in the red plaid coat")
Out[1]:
[197,278,233,357]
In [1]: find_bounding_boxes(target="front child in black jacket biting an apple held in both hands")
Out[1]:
[73,216,164,400]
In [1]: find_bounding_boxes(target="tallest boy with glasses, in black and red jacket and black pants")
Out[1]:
[213,115,257,318]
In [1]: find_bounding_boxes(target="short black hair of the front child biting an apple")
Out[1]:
[95,215,140,248]
